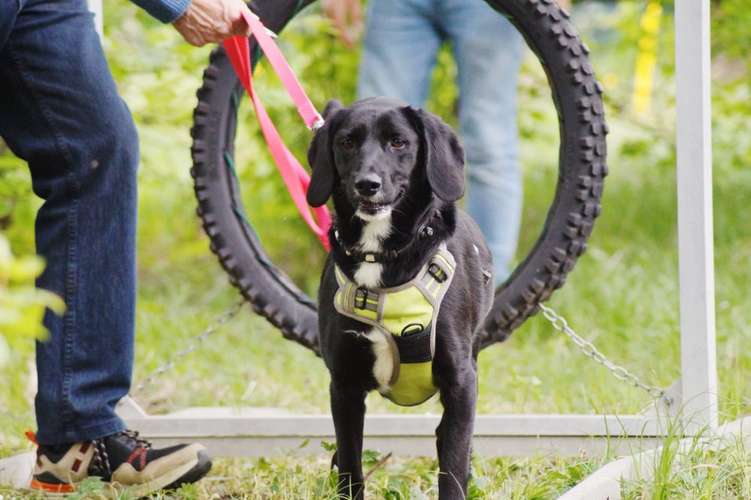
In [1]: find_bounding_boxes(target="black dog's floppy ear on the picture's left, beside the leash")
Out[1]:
[307,99,343,207]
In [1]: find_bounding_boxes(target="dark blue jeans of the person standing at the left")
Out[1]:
[0,0,138,445]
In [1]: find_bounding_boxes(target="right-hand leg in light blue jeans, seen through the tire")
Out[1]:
[441,0,523,284]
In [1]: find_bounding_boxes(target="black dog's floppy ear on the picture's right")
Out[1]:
[404,106,464,202]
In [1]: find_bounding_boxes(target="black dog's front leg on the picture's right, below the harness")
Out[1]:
[436,366,477,500]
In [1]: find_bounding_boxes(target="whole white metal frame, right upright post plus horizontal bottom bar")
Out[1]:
[120,0,717,456]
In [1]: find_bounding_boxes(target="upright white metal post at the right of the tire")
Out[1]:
[675,0,717,429]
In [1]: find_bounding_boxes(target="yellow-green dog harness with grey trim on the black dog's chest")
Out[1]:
[334,245,456,406]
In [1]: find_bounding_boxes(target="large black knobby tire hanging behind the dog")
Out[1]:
[191,0,608,354]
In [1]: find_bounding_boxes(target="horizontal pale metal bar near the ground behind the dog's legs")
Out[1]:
[121,401,665,457]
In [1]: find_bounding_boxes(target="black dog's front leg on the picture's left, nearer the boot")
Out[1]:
[329,381,366,500]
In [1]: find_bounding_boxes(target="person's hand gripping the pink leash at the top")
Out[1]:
[172,0,252,47]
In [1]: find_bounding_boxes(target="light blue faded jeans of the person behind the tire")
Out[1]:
[358,0,523,283]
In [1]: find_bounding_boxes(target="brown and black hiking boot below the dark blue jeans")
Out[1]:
[31,431,211,497]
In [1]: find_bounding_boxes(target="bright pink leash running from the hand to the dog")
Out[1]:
[224,9,331,250]
